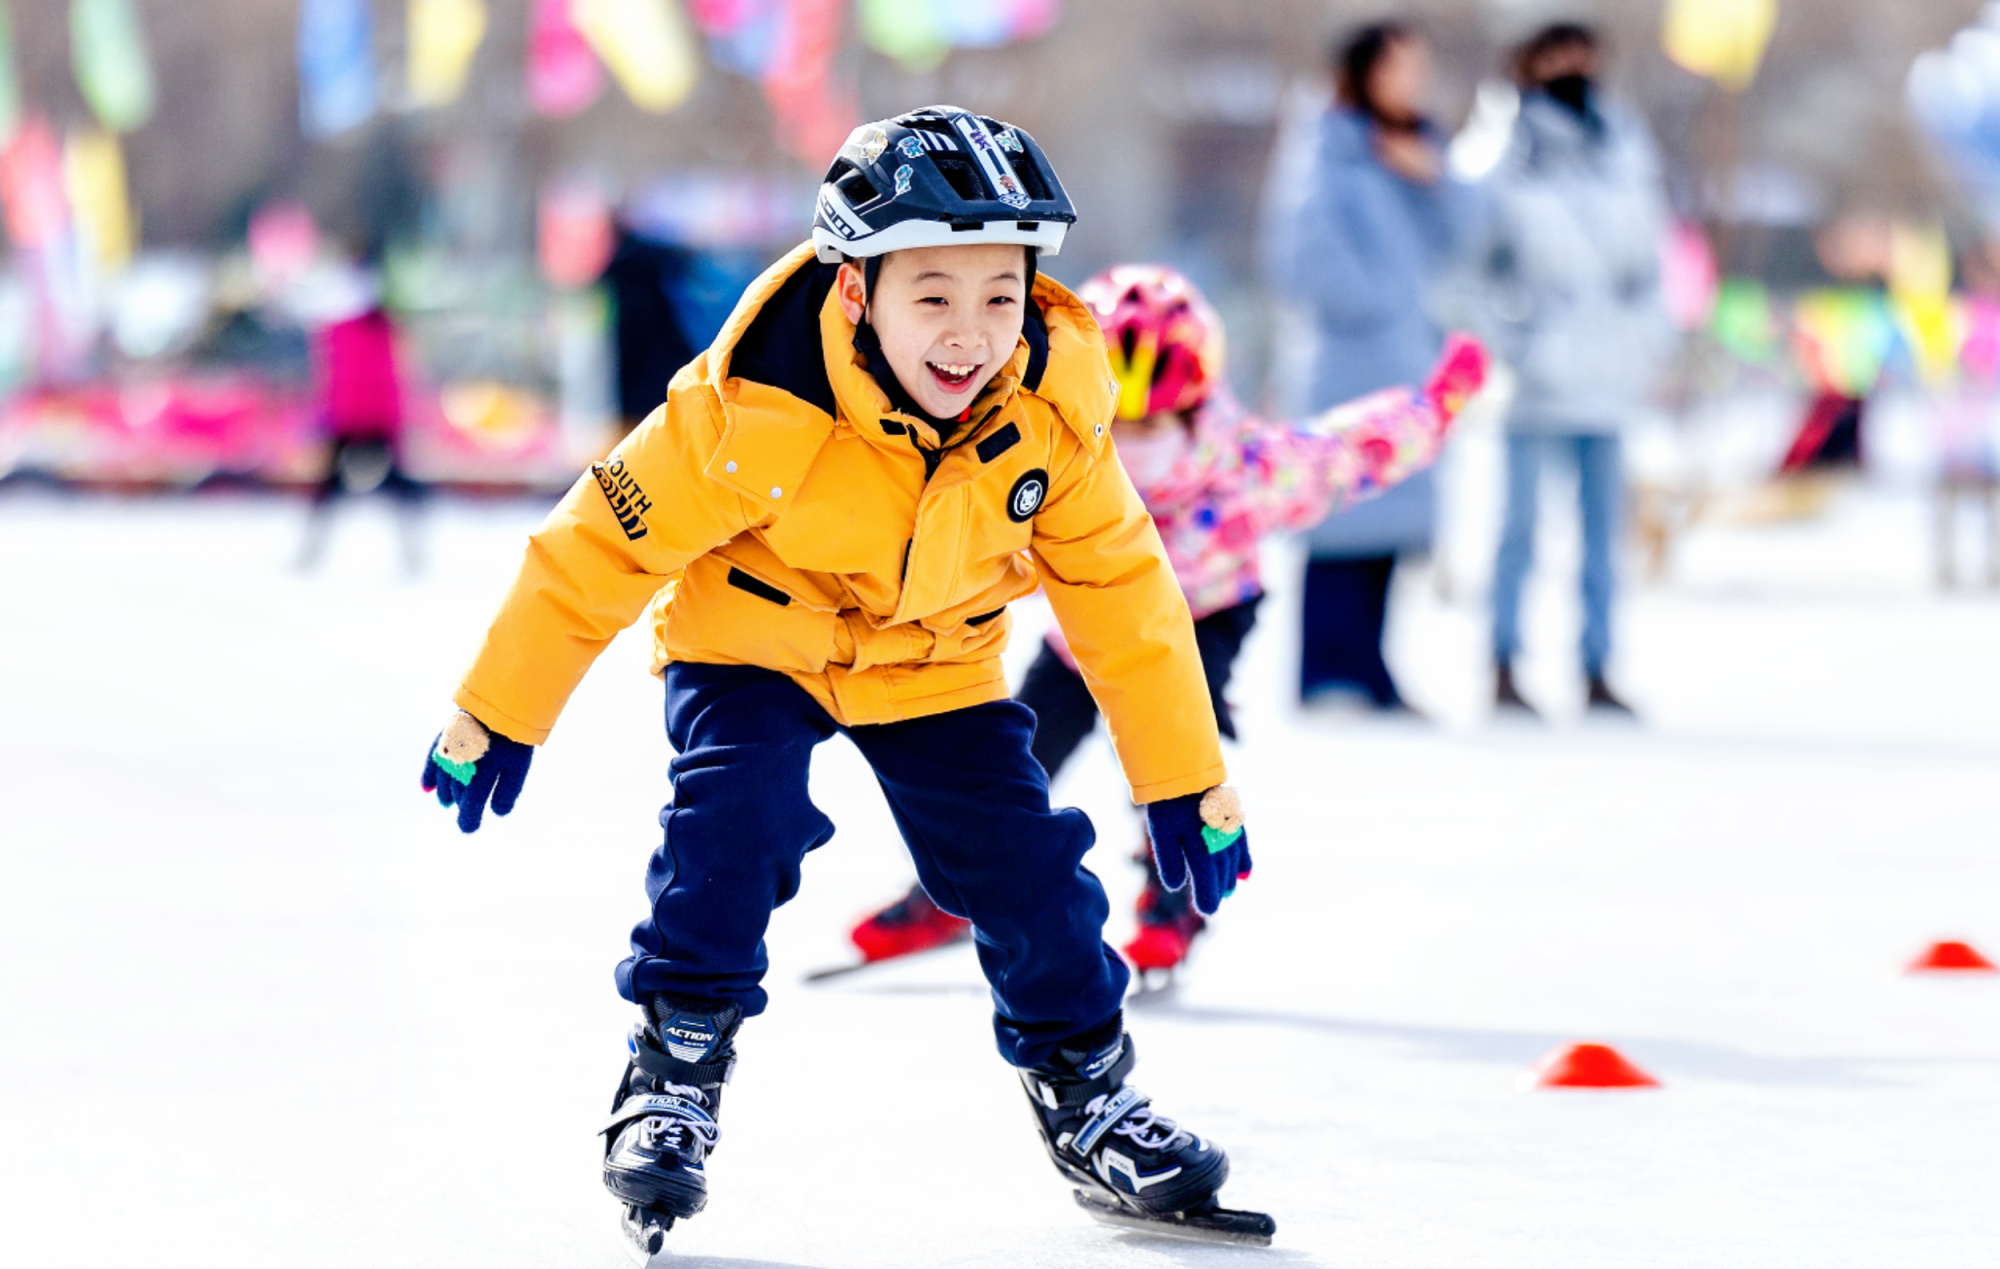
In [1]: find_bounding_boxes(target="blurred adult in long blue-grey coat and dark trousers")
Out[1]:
[1268,22,1478,711]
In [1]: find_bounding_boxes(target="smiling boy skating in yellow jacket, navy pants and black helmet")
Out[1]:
[424,106,1270,1253]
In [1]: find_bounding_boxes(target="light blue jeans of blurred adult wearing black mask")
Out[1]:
[1494,432,1624,675]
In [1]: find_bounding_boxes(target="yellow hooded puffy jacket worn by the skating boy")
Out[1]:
[454,244,1224,803]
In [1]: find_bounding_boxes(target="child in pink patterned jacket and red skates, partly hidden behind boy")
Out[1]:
[852,264,1486,973]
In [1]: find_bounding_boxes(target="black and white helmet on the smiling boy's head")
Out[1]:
[812,106,1076,264]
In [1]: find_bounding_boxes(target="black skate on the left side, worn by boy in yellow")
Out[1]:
[598,997,742,1259]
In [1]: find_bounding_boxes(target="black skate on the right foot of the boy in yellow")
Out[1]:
[1020,1035,1276,1245]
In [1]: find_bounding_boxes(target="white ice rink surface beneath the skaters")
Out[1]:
[0,478,2000,1269]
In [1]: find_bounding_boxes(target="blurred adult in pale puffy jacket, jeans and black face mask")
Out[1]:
[1486,22,1672,715]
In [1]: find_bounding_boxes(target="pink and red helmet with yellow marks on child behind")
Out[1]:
[1076,264,1222,418]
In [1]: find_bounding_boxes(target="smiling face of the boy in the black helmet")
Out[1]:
[838,242,1028,418]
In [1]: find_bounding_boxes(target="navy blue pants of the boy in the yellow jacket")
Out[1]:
[618,663,1128,1067]
